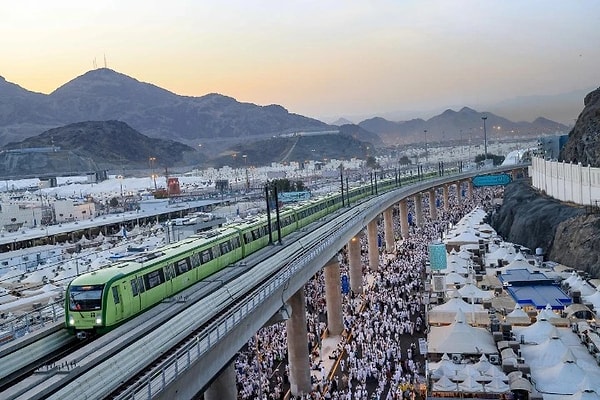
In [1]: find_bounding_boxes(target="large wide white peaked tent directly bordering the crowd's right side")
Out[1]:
[428,309,498,354]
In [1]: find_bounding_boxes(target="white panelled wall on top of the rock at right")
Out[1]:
[529,157,600,205]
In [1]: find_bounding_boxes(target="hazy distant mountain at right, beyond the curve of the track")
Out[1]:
[358,107,568,145]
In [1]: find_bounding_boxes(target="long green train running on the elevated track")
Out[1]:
[65,173,436,339]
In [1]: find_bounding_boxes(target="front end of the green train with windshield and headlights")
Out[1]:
[65,273,112,339]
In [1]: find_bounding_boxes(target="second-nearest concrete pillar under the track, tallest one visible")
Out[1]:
[285,287,312,396]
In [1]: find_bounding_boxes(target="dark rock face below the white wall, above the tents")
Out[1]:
[491,180,600,277]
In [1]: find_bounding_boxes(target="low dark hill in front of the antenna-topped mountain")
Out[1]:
[0,121,199,176]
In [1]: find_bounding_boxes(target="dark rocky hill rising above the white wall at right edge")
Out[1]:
[559,88,600,167]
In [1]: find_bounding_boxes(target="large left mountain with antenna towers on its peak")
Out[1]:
[0,68,332,150]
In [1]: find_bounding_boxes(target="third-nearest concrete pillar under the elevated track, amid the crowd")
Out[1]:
[323,256,344,336]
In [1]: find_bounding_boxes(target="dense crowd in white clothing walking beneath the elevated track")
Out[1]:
[230,188,501,400]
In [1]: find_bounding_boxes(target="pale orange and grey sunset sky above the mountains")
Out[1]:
[0,0,600,122]
